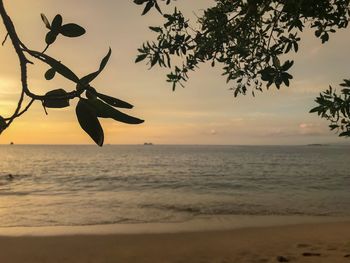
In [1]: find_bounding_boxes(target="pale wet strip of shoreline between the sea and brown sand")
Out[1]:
[0,215,350,237]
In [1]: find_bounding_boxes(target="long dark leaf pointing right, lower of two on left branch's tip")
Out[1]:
[88,99,144,124]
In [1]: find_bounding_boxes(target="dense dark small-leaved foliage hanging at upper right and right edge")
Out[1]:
[134,0,350,137]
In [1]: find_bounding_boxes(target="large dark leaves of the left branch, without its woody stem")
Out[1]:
[37,17,143,146]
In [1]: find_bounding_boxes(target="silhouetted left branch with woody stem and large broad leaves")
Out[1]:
[0,0,143,146]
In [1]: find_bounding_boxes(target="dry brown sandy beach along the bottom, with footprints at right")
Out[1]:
[0,222,350,263]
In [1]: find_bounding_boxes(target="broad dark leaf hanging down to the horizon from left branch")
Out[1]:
[75,99,104,146]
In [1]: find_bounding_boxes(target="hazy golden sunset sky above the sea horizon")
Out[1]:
[0,0,350,145]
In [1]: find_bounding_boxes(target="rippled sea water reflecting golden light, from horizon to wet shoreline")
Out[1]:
[0,145,350,227]
